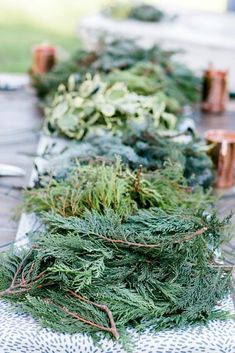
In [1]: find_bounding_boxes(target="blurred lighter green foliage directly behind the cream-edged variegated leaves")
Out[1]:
[106,62,199,106]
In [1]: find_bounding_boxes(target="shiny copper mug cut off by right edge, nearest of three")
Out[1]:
[205,129,235,188]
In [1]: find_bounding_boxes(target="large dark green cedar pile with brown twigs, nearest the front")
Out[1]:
[0,208,231,339]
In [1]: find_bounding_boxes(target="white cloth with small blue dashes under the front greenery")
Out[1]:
[0,299,235,353]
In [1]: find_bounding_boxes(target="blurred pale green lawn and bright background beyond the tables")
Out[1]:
[0,0,226,72]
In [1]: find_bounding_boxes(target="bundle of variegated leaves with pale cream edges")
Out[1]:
[45,75,177,140]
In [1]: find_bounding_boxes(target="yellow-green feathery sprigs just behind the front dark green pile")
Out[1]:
[21,160,211,218]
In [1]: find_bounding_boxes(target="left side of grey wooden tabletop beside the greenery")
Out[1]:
[0,81,42,250]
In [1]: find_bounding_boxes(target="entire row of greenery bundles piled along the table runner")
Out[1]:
[0,26,232,346]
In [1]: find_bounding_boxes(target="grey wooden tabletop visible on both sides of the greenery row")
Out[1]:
[0,76,235,261]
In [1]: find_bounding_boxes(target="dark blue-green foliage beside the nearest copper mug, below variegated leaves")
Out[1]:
[124,129,214,189]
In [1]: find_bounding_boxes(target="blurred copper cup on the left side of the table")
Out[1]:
[32,44,56,74]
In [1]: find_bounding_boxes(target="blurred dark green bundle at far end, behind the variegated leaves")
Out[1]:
[32,39,200,105]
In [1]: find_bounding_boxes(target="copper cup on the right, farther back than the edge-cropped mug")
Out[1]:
[202,67,228,113]
